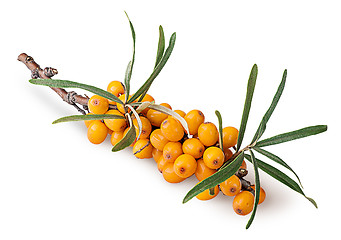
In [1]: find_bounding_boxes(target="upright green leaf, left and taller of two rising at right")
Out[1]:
[236,64,258,152]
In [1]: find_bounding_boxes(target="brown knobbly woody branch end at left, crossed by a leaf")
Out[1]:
[18,53,89,115]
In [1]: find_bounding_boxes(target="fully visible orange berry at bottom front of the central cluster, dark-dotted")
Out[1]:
[174,154,197,178]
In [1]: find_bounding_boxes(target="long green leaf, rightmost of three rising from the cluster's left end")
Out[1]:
[128,33,176,103]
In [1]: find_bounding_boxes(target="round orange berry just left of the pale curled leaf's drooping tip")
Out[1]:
[161,118,184,142]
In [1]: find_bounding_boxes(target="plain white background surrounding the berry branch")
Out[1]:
[0,0,341,240]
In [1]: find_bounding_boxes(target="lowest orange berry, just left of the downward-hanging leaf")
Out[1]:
[232,191,255,215]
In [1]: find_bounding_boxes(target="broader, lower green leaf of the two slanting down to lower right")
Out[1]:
[245,154,317,208]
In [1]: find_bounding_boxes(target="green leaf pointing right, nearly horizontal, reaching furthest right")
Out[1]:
[256,125,327,147]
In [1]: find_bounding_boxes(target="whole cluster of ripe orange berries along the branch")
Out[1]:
[85,81,265,215]
